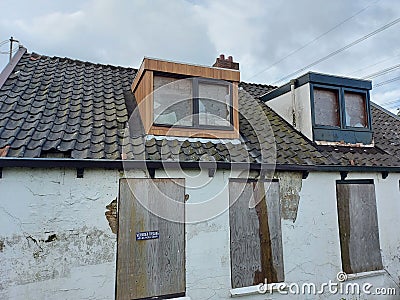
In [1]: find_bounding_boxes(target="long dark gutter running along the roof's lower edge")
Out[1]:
[0,157,400,173]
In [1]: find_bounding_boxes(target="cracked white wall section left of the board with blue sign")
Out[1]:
[0,168,118,299]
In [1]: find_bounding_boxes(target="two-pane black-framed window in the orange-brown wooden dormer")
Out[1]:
[153,75,232,129]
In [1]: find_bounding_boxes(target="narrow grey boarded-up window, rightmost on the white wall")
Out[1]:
[336,180,382,274]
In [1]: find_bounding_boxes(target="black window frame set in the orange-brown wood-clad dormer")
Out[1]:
[152,72,234,131]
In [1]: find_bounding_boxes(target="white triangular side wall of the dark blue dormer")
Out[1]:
[265,83,313,140]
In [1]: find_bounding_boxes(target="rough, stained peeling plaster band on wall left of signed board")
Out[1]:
[0,227,115,286]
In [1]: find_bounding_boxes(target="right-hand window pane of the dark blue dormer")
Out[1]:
[344,91,368,128]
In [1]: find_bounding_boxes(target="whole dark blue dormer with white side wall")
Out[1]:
[261,72,372,145]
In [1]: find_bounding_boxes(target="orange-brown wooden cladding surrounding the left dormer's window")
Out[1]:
[131,57,240,139]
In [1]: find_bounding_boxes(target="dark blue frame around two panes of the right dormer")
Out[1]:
[310,83,372,132]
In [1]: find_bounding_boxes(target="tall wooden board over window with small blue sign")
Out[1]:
[116,178,185,300]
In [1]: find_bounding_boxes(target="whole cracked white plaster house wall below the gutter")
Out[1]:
[0,169,400,300]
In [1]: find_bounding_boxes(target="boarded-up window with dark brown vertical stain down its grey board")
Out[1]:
[229,180,284,288]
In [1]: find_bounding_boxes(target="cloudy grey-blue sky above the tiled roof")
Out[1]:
[0,0,400,112]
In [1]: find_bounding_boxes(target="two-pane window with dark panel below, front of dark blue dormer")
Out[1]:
[311,84,372,144]
